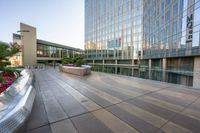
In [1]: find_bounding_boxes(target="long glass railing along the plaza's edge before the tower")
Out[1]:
[90,64,195,86]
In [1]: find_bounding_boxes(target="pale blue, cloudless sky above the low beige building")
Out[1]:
[0,0,84,49]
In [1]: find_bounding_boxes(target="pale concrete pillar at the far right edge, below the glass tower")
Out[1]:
[193,57,200,89]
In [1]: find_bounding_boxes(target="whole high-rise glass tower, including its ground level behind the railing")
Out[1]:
[85,0,200,87]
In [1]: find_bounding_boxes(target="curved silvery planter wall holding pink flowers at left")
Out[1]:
[0,70,36,133]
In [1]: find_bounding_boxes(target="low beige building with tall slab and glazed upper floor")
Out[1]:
[11,23,83,66]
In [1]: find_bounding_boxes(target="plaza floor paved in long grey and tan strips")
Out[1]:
[26,68,200,133]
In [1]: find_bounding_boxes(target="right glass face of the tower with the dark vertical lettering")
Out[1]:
[143,0,200,58]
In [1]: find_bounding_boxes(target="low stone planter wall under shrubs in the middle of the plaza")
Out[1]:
[62,66,91,76]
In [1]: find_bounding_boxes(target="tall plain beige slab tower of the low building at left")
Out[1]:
[20,23,37,66]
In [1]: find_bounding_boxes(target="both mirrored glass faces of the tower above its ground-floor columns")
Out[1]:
[85,0,200,59]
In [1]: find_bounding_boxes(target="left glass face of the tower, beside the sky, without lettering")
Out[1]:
[85,0,143,59]
